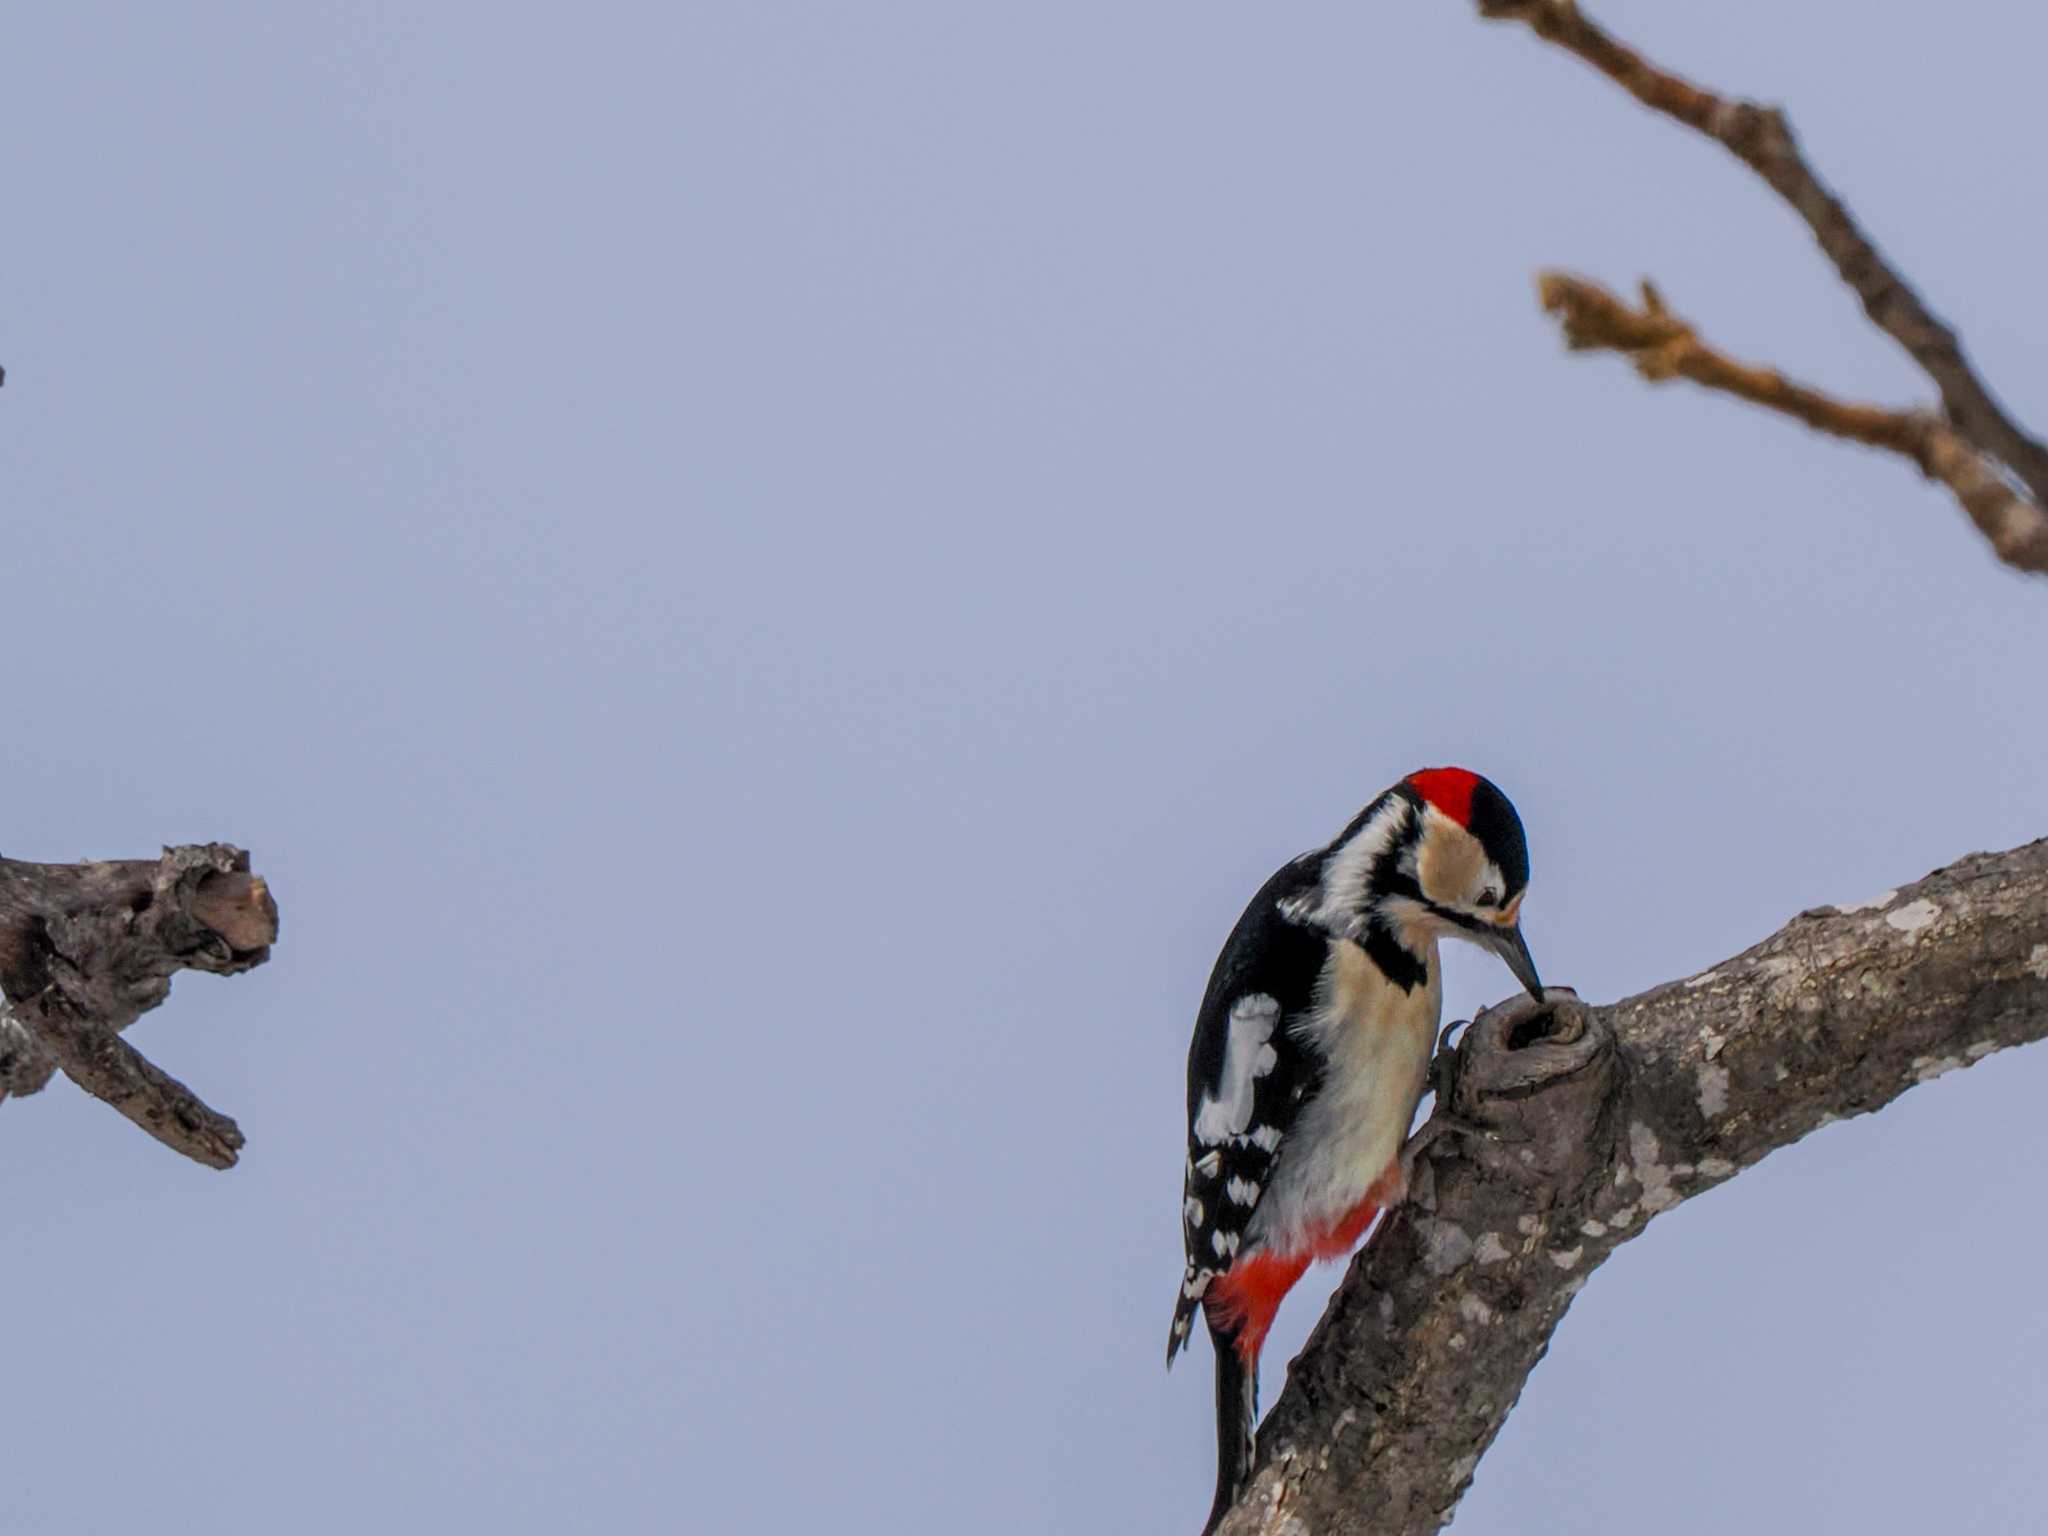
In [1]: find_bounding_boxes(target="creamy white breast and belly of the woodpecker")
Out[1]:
[1247,940,1444,1253]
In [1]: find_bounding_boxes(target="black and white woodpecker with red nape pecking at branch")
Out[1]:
[1165,768,1544,1536]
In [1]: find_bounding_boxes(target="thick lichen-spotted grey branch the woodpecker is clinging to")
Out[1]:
[1219,842,2048,1536]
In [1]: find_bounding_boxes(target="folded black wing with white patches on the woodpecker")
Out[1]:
[1165,854,1329,1366]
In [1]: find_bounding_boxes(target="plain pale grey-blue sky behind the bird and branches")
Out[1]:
[0,0,2048,1536]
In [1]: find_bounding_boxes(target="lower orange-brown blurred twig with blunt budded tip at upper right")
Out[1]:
[1536,272,2048,575]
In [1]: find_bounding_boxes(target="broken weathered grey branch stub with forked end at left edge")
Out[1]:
[0,844,276,1167]
